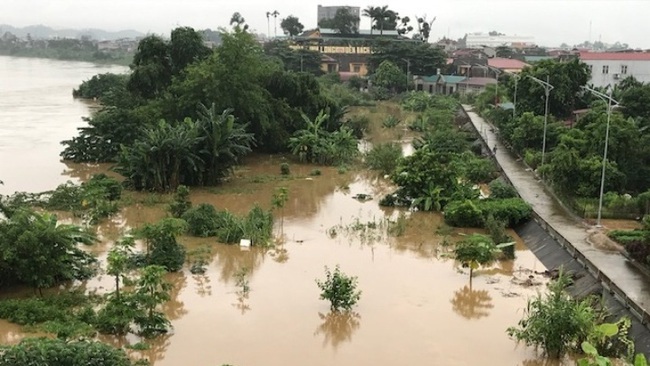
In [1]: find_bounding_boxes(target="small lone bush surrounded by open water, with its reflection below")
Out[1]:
[316,265,361,311]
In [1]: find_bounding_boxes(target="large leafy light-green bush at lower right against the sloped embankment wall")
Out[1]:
[507,273,599,358]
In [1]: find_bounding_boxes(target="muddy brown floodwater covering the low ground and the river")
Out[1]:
[0,57,568,366]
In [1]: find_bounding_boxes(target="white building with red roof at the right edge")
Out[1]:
[580,52,650,87]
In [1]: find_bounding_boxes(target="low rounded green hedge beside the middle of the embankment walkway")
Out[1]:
[444,198,532,227]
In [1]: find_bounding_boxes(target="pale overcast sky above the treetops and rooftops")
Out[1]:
[0,0,650,48]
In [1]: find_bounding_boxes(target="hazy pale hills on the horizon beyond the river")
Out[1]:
[0,24,145,41]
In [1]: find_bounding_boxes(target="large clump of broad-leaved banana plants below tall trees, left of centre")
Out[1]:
[115,104,253,191]
